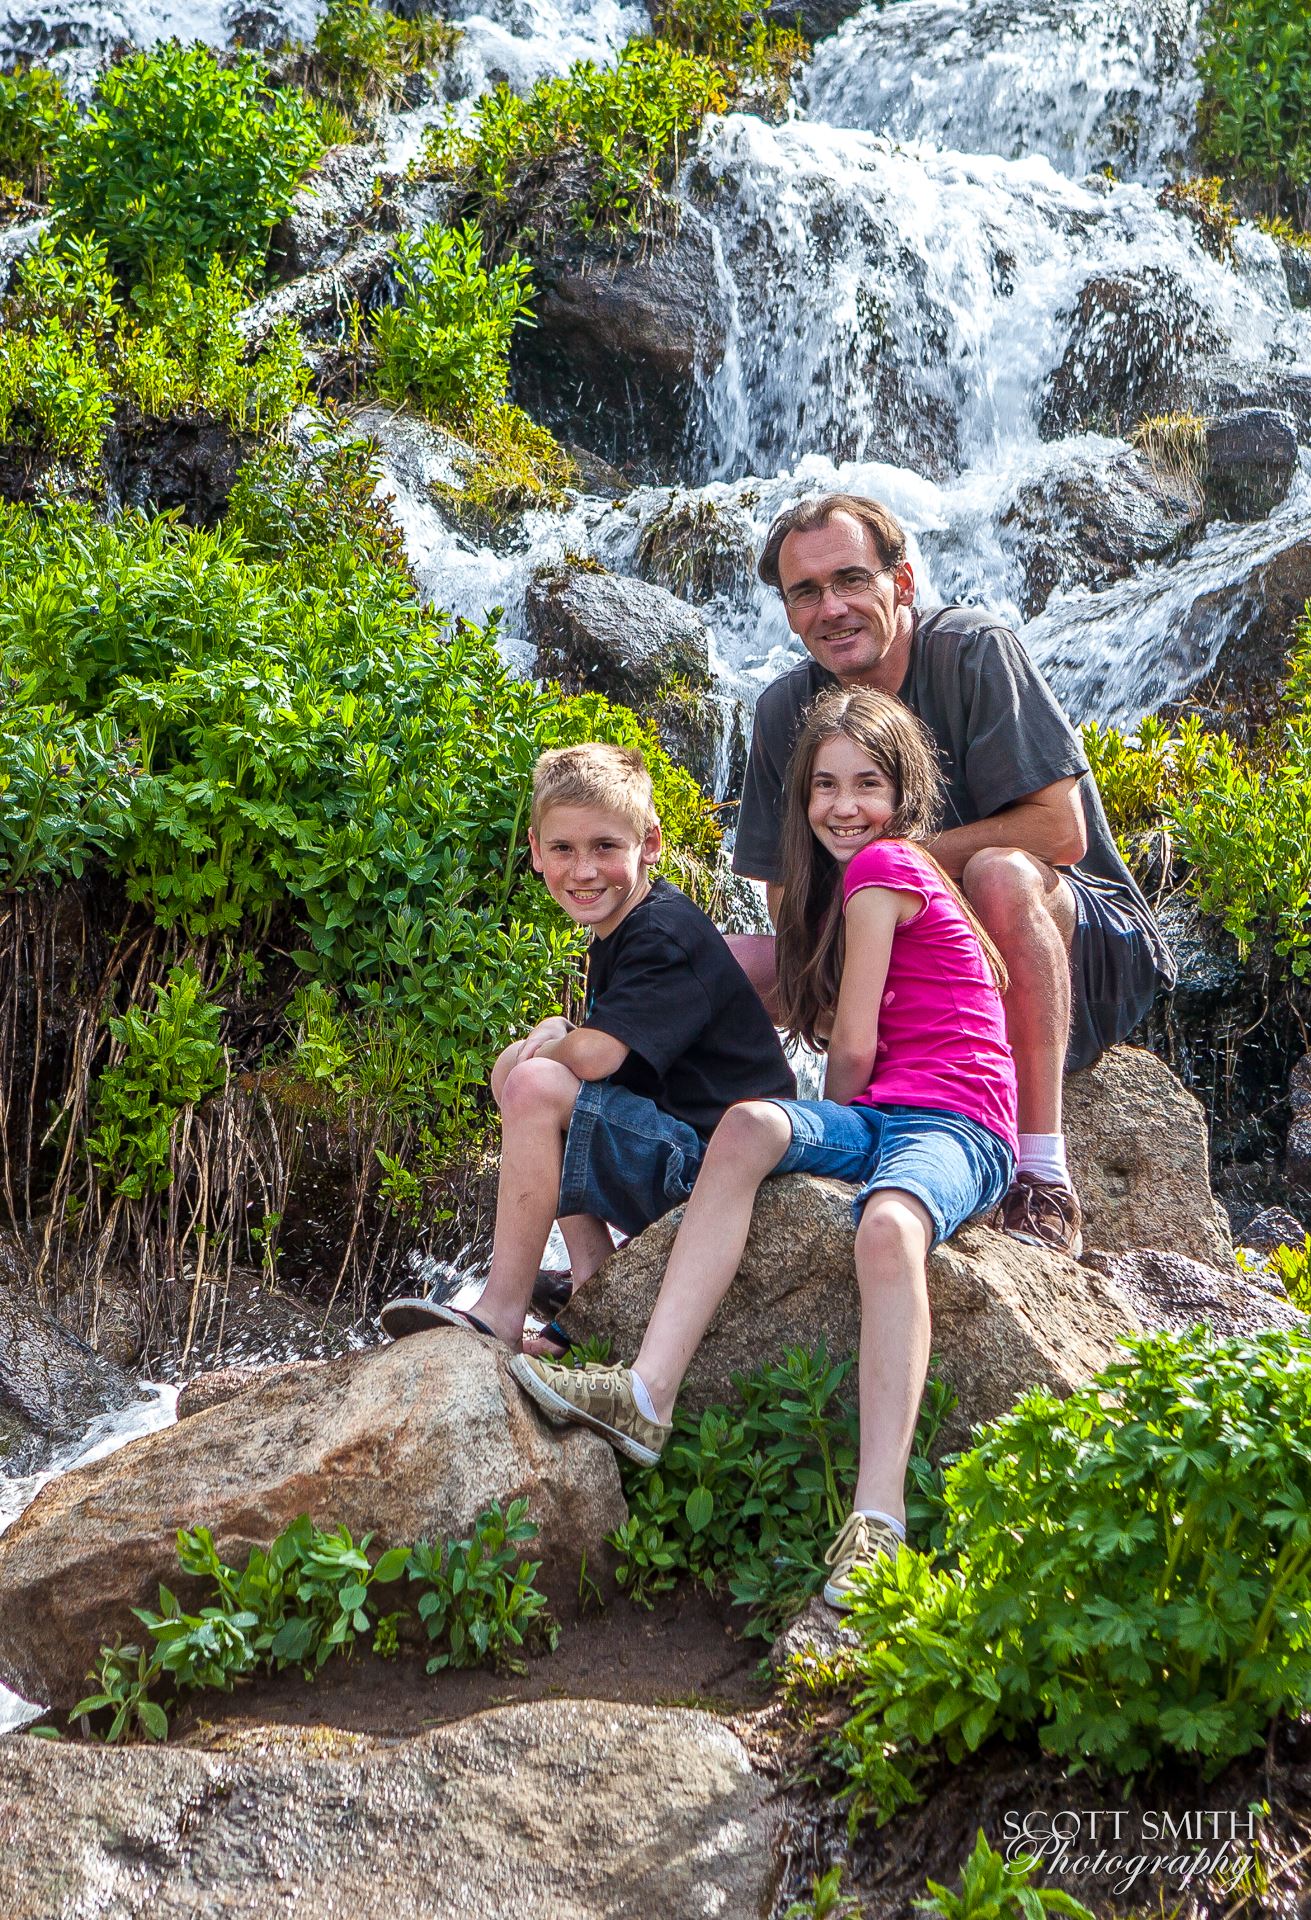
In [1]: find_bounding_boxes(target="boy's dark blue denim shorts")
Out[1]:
[557,1081,706,1233]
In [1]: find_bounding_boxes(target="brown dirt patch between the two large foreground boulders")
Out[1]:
[171,1590,770,1747]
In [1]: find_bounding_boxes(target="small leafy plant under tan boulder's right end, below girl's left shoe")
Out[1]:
[407,1500,560,1674]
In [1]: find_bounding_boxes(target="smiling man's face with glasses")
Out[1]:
[779,513,914,693]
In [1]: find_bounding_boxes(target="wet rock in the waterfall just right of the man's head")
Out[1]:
[1000,444,1202,620]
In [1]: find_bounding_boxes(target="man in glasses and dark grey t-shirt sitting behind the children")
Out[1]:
[733,493,1175,1258]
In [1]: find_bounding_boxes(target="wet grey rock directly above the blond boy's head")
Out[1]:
[524,564,710,710]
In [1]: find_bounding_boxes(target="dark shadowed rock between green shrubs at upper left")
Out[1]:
[102,405,257,526]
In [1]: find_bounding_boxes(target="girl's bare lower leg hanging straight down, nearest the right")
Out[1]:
[852,1190,933,1523]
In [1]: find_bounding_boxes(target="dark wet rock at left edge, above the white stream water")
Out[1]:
[0,1286,138,1476]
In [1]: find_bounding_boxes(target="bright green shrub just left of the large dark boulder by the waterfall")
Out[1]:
[374,221,532,430]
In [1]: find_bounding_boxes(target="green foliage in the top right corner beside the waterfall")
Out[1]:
[1198,0,1311,225]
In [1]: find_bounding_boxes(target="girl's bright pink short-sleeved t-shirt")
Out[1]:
[843,841,1019,1152]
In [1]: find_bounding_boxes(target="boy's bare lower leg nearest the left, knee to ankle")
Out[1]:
[478,1056,583,1346]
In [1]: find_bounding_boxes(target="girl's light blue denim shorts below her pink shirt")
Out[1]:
[774,1100,1015,1246]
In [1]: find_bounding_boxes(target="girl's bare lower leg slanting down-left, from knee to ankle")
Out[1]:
[633,1100,793,1425]
